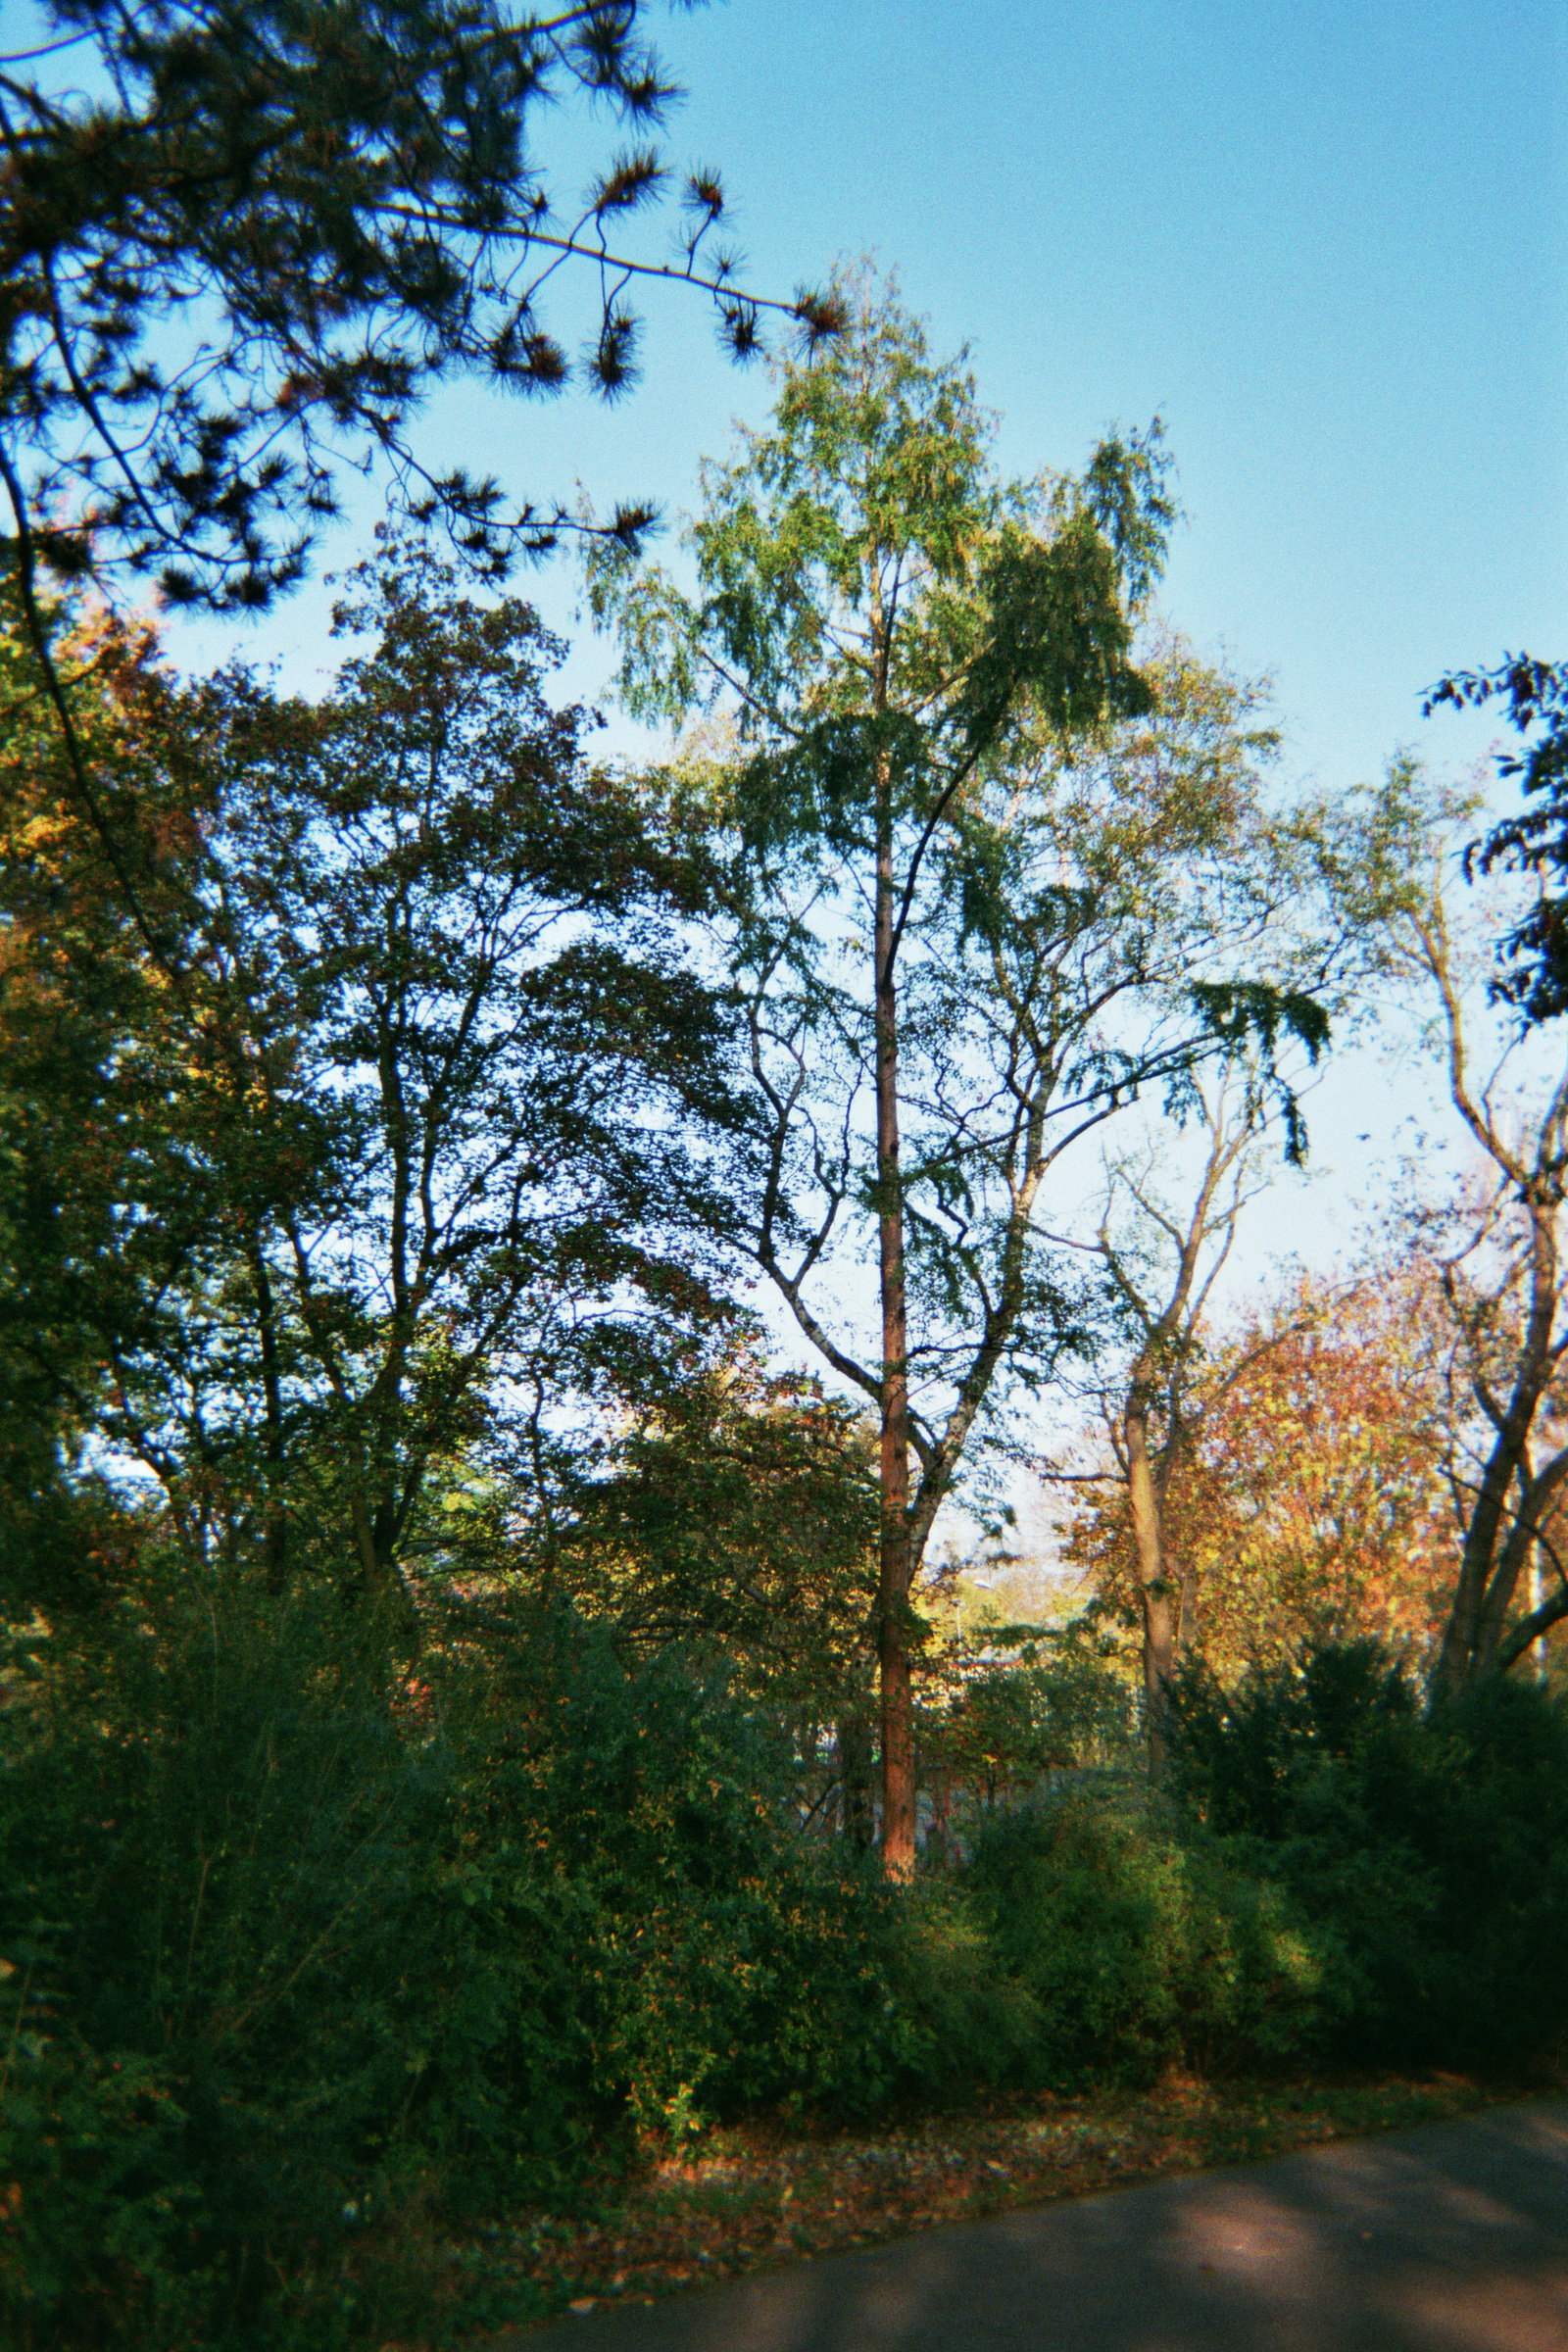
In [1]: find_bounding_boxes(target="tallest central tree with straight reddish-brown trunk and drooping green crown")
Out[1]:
[590,277,1321,1875]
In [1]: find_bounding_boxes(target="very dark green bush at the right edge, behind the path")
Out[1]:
[1173,1644,1568,2070]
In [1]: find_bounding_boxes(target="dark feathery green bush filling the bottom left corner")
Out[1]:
[0,1594,533,2347]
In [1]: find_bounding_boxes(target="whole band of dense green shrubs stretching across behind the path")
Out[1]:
[0,1578,1568,2352]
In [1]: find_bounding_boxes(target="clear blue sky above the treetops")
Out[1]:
[166,0,1568,1307]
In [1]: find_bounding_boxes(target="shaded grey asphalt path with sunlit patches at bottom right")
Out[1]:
[514,2100,1568,2352]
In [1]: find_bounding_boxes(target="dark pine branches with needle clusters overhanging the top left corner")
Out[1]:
[0,0,835,612]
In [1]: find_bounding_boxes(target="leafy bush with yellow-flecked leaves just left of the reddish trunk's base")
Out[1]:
[441,1613,901,2133]
